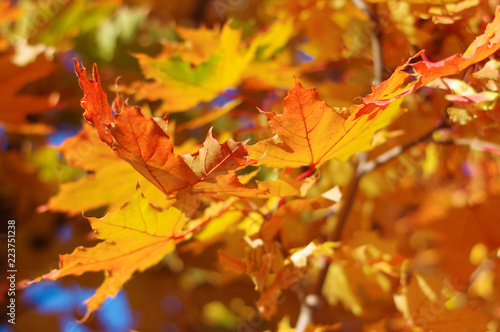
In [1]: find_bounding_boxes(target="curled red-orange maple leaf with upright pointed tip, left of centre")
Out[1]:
[75,60,265,195]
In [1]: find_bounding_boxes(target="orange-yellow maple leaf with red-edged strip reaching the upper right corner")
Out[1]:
[249,8,500,167]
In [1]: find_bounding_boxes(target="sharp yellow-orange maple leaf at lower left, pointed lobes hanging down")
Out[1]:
[32,188,187,320]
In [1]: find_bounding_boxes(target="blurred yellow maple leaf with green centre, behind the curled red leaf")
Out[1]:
[124,20,292,113]
